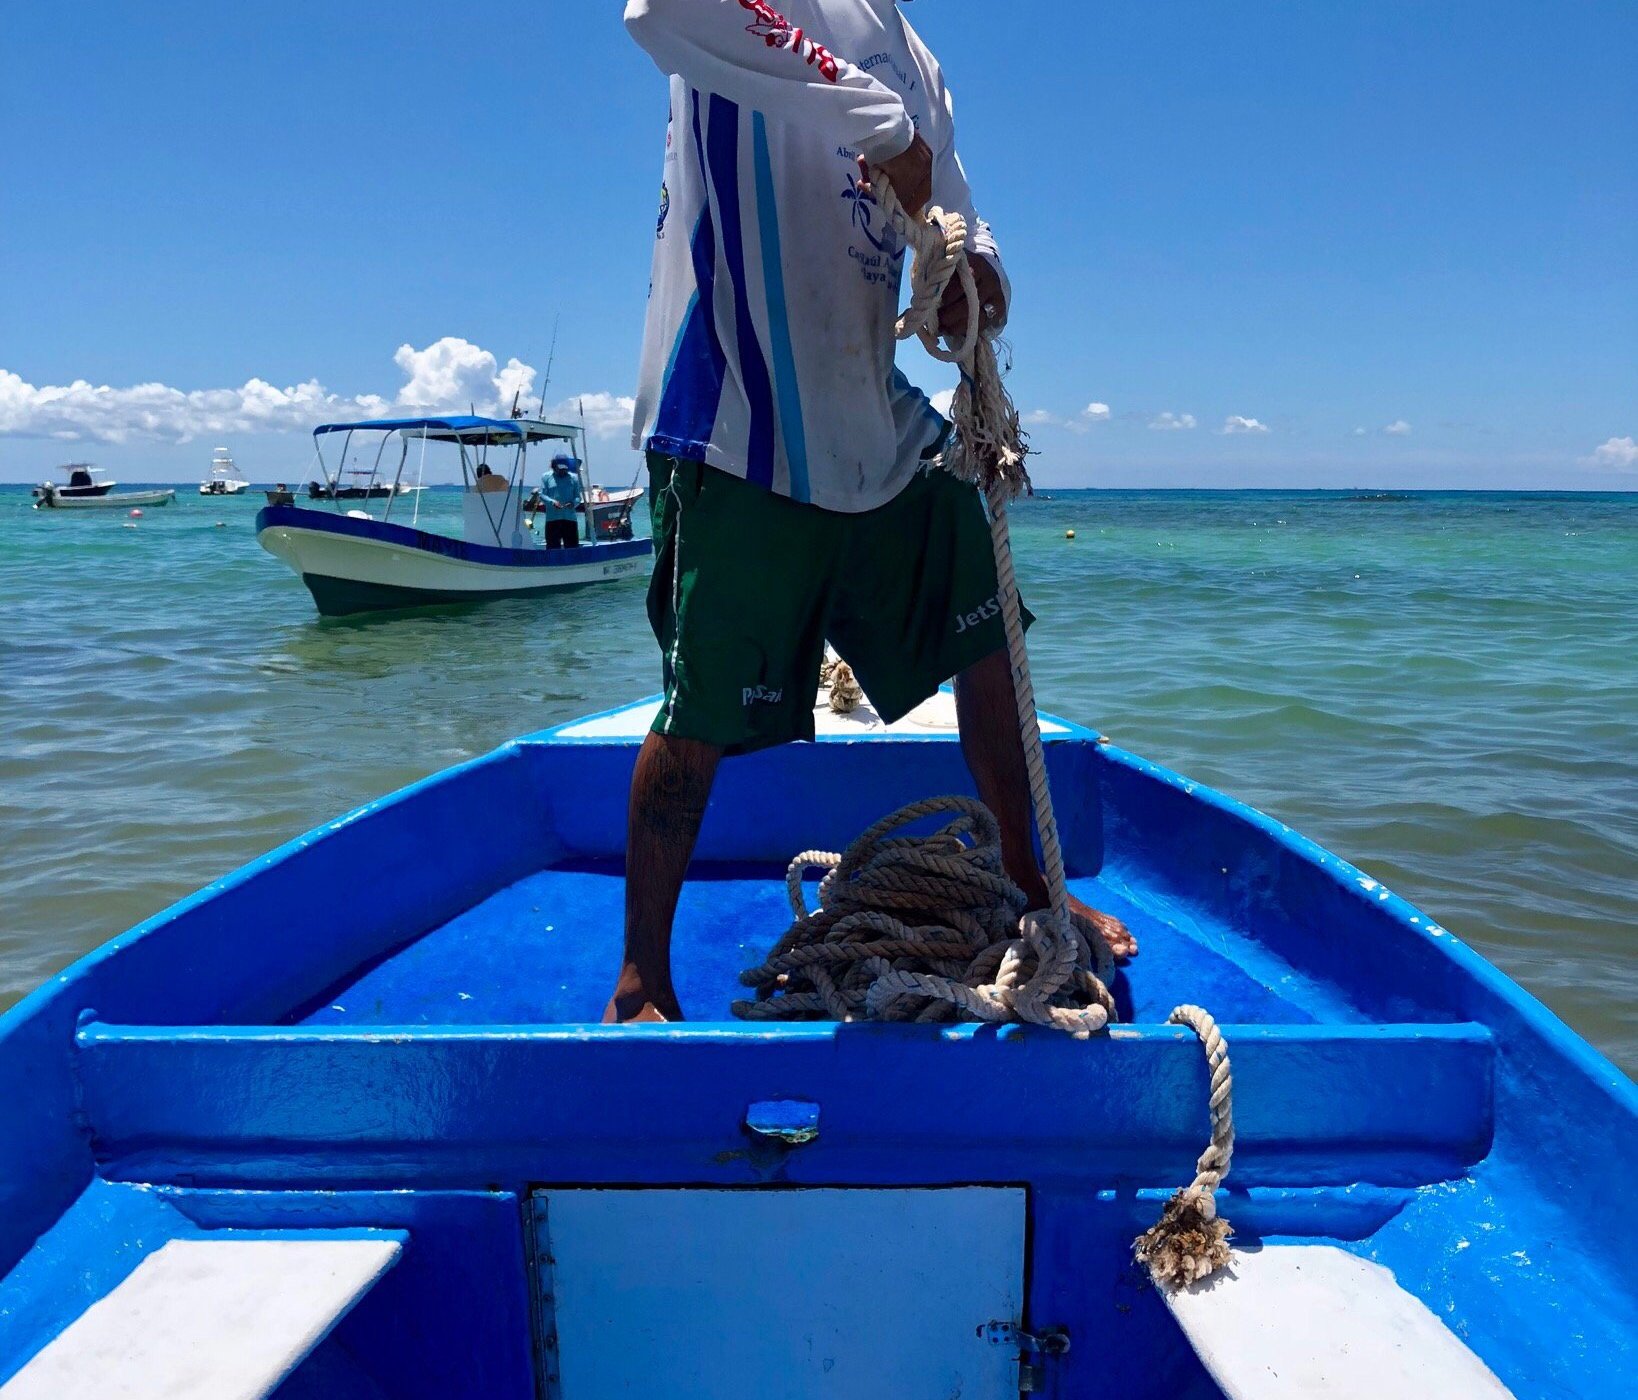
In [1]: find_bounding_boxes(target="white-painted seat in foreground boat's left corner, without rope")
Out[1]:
[0,1235,401,1400]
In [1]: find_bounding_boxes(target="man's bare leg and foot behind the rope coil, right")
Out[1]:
[955,648,1137,958]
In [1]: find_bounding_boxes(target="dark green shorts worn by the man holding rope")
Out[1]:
[649,452,1030,753]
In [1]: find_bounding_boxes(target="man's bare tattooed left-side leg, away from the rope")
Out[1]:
[603,734,722,1022]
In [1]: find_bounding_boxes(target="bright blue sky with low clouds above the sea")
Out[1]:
[0,0,1638,488]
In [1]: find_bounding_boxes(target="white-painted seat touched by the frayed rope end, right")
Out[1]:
[1161,1244,1510,1400]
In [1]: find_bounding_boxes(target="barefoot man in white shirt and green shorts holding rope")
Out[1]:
[606,0,1130,1020]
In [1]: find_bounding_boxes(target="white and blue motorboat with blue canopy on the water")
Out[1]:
[256,414,654,616]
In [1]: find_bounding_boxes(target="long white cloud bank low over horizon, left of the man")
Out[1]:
[0,336,632,444]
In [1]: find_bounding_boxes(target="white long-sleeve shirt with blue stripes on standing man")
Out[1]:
[626,0,1006,511]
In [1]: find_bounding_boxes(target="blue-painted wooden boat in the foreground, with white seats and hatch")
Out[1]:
[0,694,1638,1400]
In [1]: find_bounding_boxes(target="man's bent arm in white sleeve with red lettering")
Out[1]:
[626,0,916,164]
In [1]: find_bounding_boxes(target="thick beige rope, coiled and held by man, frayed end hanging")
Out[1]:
[734,170,1233,1285]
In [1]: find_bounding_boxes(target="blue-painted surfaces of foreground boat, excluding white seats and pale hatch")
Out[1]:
[0,707,1638,1400]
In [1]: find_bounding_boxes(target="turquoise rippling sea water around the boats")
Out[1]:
[0,488,1638,1073]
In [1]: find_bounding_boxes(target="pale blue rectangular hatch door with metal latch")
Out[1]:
[529,1187,1025,1400]
